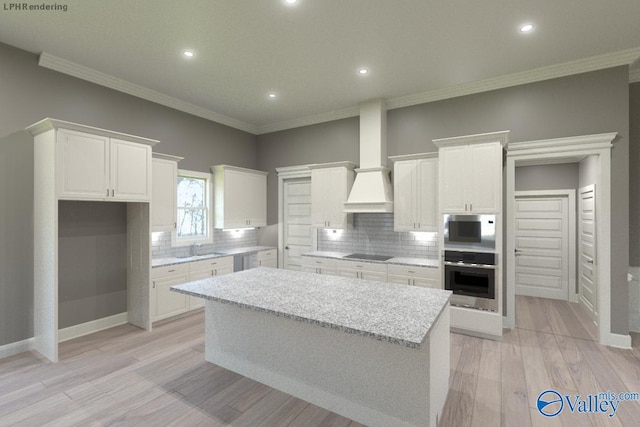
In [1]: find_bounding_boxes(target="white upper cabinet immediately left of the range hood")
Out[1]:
[310,162,355,229]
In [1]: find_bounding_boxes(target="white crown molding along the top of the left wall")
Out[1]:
[38,52,257,135]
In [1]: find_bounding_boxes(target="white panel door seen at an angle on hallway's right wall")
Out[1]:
[578,185,598,322]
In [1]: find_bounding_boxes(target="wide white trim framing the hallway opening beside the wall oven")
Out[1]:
[503,132,620,348]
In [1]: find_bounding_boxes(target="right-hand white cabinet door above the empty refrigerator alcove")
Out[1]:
[111,138,151,201]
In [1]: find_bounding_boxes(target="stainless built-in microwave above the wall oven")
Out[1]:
[444,215,496,250]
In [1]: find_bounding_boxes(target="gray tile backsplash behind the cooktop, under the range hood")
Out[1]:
[318,213,439,259]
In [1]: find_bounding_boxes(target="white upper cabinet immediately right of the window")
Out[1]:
[211,165,268,229]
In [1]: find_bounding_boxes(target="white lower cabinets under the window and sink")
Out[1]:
[151,256,233,321]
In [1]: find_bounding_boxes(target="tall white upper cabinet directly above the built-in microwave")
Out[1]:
[433,131,508,214]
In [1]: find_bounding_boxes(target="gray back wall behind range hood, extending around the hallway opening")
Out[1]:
[258,67,636,334]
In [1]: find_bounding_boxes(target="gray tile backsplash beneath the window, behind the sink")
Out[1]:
[151,229,258,258]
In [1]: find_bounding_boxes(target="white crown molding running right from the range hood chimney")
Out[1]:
[386,47,640,110]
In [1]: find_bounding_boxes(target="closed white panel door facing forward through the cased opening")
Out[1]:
[515,197,570,301]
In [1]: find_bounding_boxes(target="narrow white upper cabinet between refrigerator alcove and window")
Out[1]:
[151,153,182,231]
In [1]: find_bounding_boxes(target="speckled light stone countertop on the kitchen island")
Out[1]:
[171,267,451,348]
